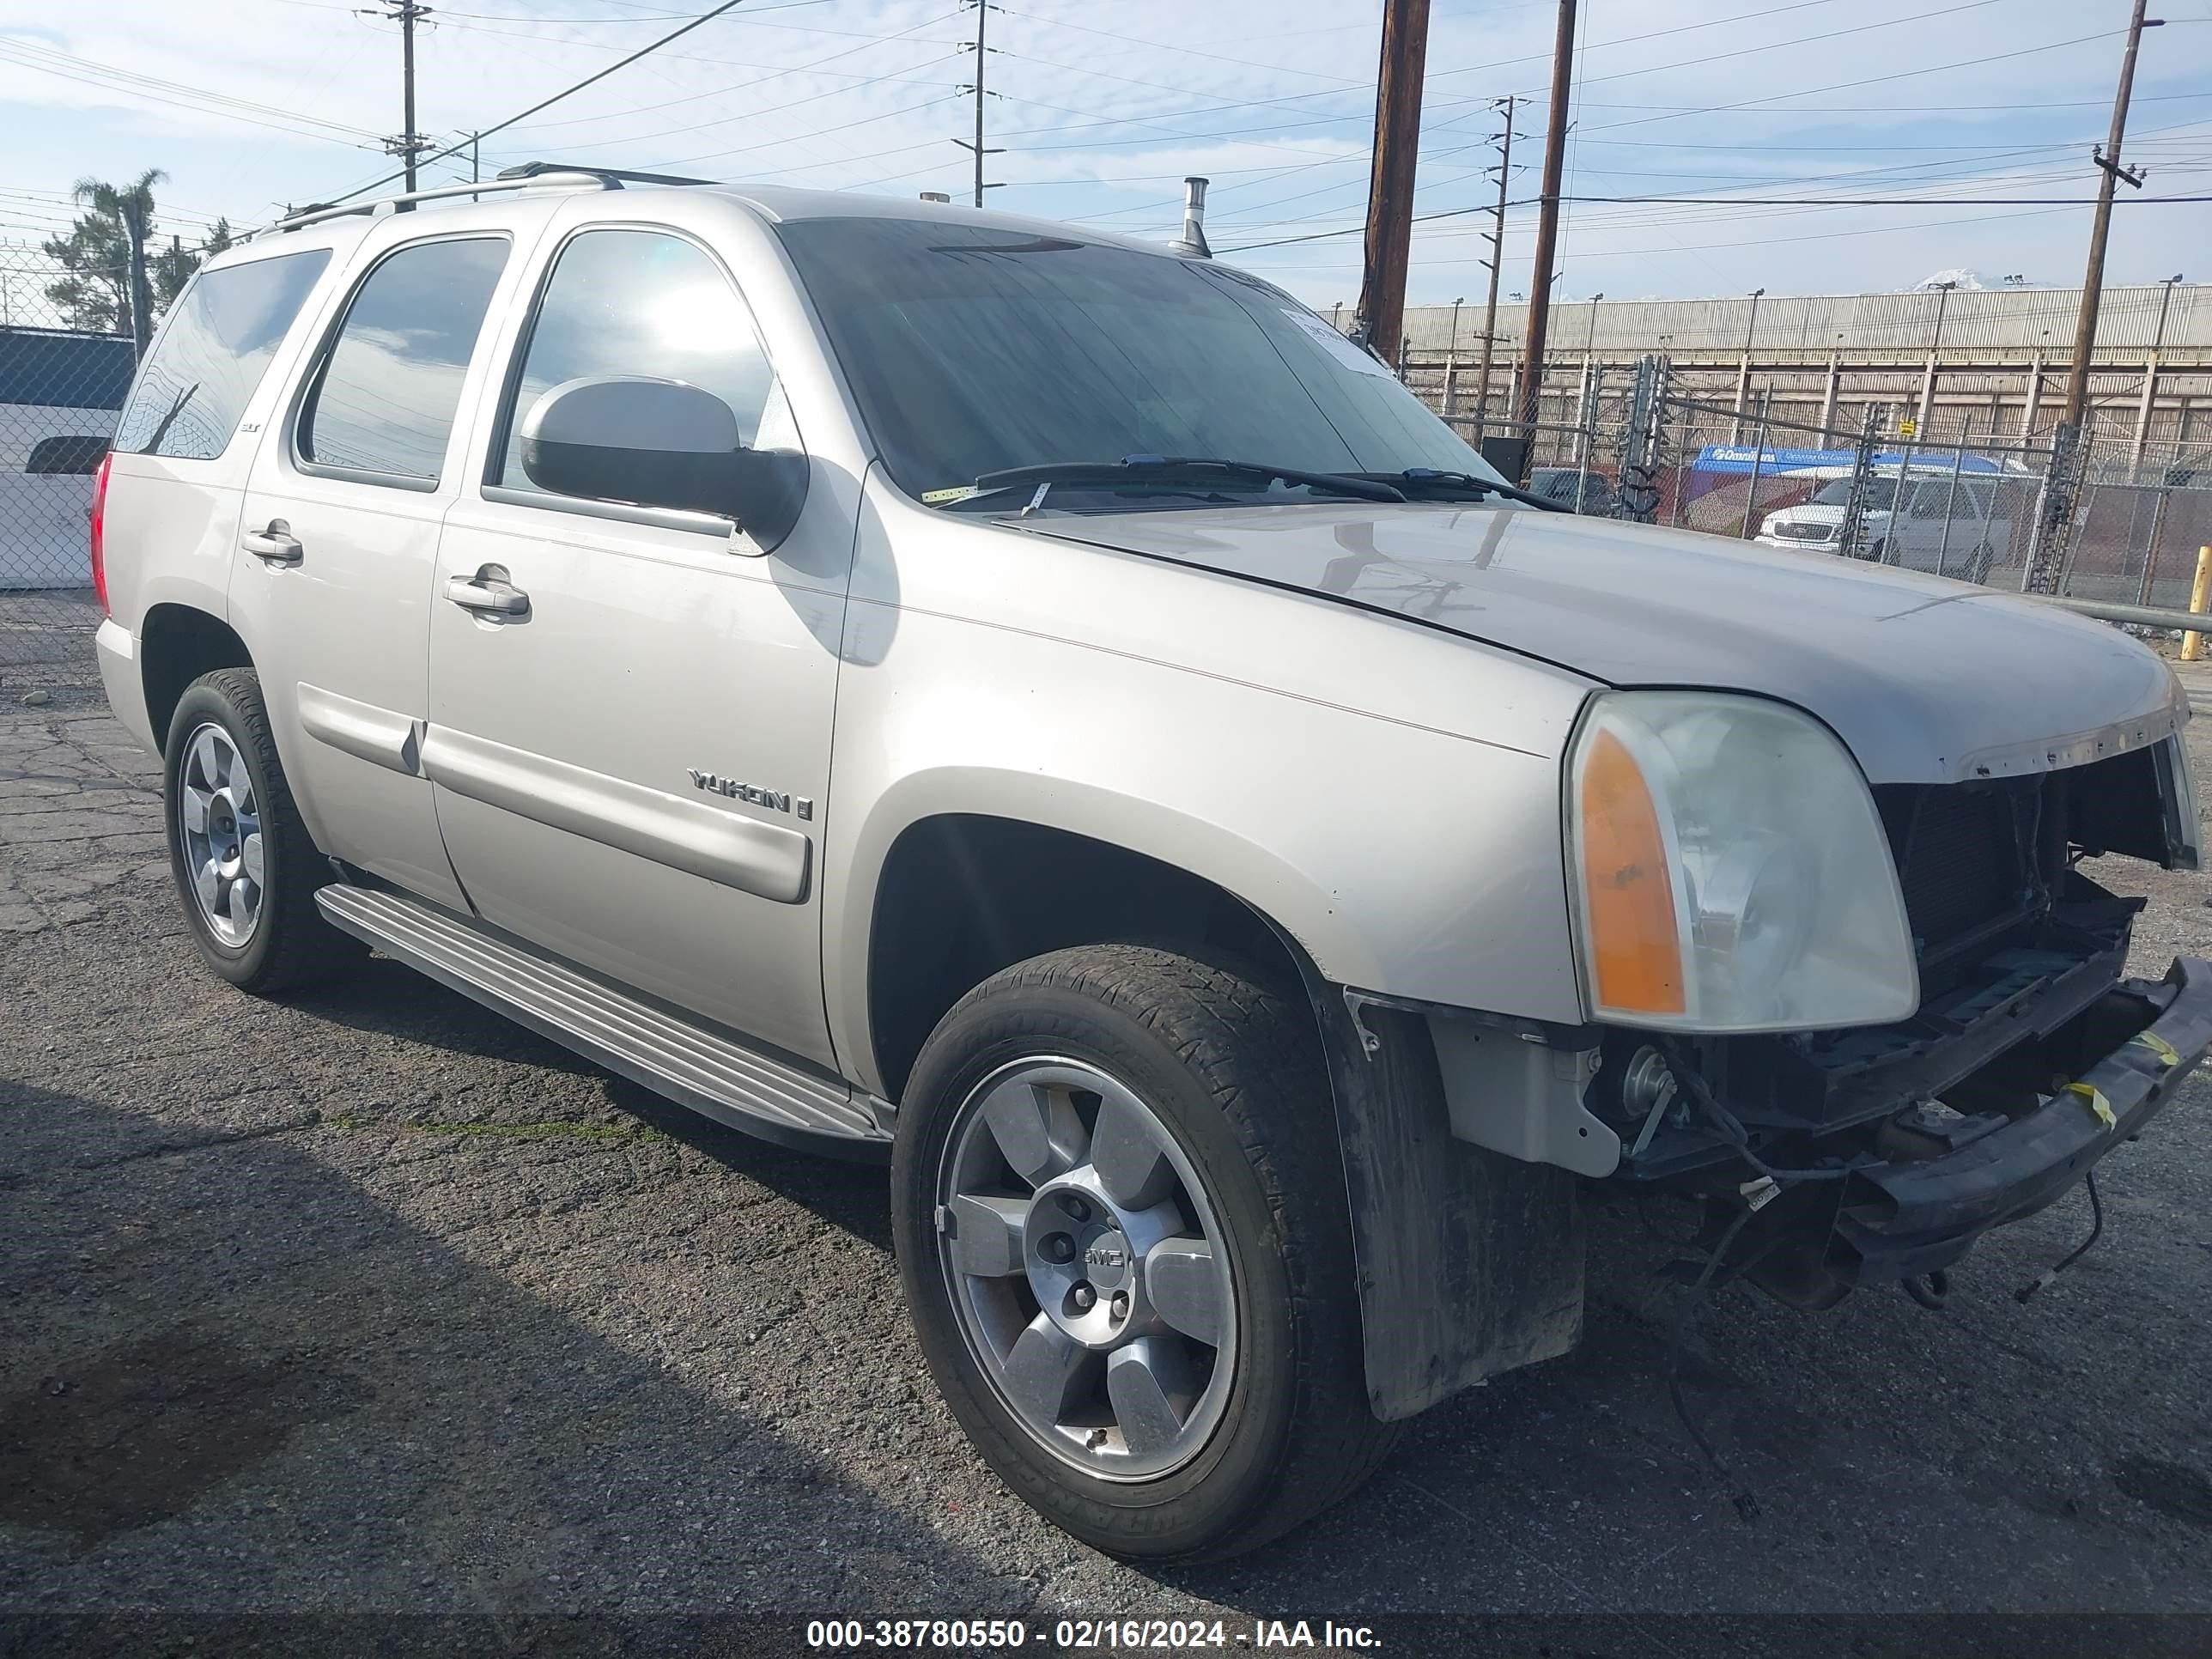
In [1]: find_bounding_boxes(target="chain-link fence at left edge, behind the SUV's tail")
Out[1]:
[0,243,137,690]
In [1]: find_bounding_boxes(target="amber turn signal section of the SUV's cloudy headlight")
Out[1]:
[1582,730,1683,1013]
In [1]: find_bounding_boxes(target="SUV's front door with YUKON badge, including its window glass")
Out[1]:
[422,223,854,1066]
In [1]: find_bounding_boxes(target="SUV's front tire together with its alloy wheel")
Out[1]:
[891,945,1395,1562]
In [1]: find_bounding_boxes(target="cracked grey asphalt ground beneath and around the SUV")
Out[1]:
[0,654,2212,1652]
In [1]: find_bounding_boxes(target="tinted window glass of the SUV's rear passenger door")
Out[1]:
[299,237,507,489]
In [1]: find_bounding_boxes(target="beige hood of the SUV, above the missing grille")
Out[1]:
[1022,504,2188,783]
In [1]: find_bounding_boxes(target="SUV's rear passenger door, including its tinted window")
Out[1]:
[230,215,532,905]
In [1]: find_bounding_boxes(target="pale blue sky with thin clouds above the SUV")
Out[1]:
[0,0,2212,307]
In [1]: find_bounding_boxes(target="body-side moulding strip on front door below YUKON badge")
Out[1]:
[422,726,814,905]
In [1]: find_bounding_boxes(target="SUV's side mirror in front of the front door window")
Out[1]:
[520,374,807,549]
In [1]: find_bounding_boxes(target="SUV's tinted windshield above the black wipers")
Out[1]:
[776,219,1498,507]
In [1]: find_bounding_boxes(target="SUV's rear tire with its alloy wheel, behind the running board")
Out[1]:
[161,668,368,995]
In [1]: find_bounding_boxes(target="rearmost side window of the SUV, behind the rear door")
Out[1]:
[115,248,330,460]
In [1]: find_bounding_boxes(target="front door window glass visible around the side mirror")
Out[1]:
[497,230,792,489]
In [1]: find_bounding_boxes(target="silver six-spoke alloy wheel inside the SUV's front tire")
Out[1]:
[936,1057,1237,1480]
